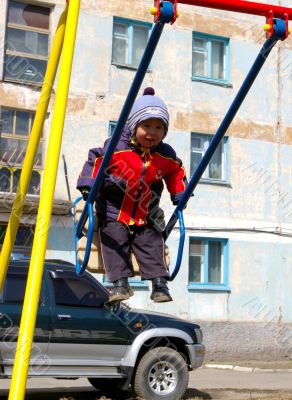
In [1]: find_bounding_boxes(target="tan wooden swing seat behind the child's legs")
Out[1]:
[75,200,170,276]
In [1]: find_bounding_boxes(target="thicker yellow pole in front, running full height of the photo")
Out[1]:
[9,0,80,400]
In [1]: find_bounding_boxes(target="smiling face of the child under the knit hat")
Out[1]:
[136,118,165,148]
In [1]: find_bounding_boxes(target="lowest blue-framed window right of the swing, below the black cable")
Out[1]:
[189,238,228,290]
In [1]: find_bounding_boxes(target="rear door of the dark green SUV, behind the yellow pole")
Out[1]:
[0,266,50,375]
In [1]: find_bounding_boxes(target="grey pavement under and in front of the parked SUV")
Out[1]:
[0,362,292,400]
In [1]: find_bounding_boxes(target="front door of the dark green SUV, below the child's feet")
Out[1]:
[48,270,129,367]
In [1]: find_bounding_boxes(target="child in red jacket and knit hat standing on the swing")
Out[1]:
[77,88,187,303]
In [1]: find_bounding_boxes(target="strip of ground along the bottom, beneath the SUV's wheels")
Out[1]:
[0,361,292,400]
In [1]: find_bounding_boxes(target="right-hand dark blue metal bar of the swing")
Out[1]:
[163,19,286,240]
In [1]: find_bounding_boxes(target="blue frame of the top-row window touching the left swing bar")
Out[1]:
[111,16,153,71]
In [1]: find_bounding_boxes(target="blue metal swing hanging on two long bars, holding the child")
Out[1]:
[74,0,289,281]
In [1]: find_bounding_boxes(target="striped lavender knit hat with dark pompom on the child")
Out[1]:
[128,87,169,135]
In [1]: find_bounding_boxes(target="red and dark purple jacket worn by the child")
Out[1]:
[77,126,187,226]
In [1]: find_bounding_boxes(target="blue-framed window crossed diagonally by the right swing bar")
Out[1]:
[191,133,228,183]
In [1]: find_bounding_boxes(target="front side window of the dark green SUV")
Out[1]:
[52,278,104,307]
